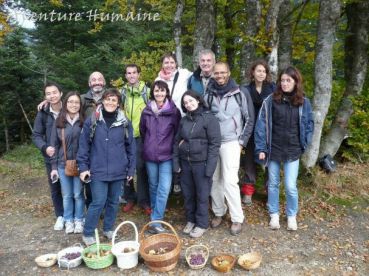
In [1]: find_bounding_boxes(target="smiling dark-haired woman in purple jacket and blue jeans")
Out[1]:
[140,80,181,233]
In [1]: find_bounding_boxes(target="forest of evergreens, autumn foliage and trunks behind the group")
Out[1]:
[0,0,369,168]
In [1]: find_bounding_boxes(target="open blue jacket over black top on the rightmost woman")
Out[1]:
[254,94,314,165]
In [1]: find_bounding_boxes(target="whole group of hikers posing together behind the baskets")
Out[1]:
[33,50,314,245]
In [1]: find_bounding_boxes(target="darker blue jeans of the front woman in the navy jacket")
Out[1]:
[83,179,123,237]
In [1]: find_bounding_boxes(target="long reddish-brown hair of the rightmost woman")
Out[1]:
[273,66,304,106]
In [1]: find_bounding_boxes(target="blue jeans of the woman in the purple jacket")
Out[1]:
[146,160,173,226]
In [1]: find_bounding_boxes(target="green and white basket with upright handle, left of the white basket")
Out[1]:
[82,230,114,269]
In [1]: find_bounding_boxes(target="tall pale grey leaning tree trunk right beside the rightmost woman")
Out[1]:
[302,0,341,168]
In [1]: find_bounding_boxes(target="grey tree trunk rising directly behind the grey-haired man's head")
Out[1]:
[193,0,216,68]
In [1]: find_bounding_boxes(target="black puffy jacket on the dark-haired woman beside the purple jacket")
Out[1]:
[173,106,221,177]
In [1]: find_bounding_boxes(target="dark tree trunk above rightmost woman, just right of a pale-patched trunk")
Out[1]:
[277,0,293,68]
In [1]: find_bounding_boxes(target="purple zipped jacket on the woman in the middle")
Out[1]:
[140,100,181,162]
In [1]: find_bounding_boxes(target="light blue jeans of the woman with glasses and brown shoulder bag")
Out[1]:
[58,168,85,222]
